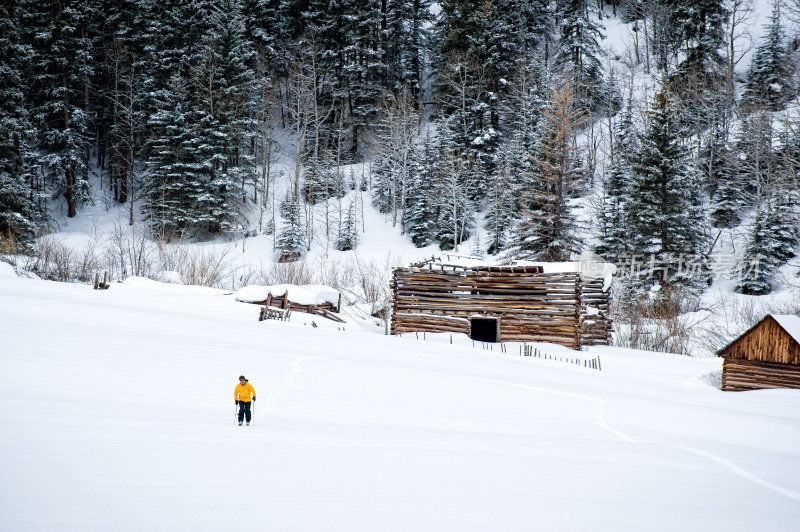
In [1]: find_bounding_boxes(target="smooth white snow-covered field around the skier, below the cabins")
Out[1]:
[0,264,800,532]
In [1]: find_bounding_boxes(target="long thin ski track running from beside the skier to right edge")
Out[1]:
[270,353,800,502]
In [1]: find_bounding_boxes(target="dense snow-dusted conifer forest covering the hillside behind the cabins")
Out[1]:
[0,0,800,300]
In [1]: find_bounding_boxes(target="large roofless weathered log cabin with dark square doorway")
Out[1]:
[391,261,611,349]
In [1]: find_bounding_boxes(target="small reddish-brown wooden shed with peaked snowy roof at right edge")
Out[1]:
[717,314,800,391]
